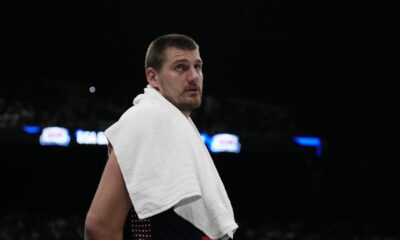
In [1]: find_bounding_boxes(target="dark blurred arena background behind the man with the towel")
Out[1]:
[0,0,400,240]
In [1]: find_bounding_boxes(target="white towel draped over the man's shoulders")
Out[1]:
[105,85,238,239]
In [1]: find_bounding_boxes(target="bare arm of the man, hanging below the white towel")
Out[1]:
[85,146,132,240]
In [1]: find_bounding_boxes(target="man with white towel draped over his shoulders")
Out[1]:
[85,34,238,240]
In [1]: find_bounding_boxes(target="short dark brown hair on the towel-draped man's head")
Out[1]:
[144,33,199,71]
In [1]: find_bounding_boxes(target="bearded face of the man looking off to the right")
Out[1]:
[157,48,203,116]
